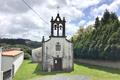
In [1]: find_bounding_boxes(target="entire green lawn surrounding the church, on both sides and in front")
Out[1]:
[14,60,120,80]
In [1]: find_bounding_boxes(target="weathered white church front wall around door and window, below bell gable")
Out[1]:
[43,37,73,69]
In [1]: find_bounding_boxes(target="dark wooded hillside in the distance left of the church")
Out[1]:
[0,38,42,59]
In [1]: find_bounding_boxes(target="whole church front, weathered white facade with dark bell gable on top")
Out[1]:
[42,14,73,72]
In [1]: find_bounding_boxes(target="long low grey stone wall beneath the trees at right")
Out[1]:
[75,59,120,69]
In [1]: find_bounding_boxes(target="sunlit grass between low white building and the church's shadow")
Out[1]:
[14,60,37,80]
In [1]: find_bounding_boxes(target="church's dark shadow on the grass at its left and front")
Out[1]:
[34,64,69,75]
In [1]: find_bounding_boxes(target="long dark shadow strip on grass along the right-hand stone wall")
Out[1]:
[75,62,120,75]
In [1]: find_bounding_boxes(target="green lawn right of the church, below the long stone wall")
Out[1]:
[71,64,120,80]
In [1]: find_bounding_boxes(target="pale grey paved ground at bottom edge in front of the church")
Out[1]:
[31,75,90,80]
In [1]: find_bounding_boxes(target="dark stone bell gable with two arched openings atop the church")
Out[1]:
[50,13,66,37]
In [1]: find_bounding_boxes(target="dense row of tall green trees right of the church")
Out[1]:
[72,10,120,61]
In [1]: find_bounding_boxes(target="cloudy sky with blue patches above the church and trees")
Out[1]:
[0,0,120,41]
